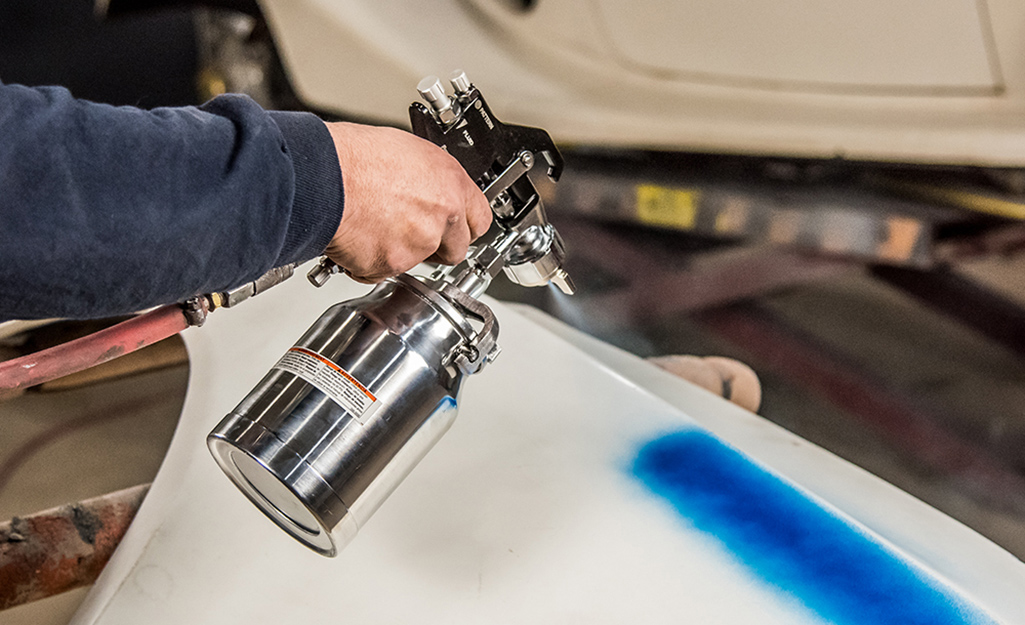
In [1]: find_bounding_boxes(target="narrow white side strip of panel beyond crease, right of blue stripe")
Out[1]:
[515,305,1025,623]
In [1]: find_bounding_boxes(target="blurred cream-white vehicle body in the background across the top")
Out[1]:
[260,0,1025,167]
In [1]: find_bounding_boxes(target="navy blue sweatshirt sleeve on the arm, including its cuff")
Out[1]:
[0,84,343,320]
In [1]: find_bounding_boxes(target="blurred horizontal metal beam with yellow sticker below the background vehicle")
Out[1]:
[546,155,963,267]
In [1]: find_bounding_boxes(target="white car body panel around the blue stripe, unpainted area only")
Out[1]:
[73,270,1025,625]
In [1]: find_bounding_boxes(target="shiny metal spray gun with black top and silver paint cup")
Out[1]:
[207,72,574,556]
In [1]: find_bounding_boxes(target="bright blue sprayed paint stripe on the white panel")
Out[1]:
[632,430,994,625]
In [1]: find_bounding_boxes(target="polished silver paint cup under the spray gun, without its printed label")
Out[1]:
[208,277,483,555]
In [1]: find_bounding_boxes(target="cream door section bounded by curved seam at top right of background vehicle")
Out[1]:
[596,0,995,91]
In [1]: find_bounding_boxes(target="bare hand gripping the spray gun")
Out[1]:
[325,123,491,283]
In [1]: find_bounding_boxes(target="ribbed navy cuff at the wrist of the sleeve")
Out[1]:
[270,111,344,266]
